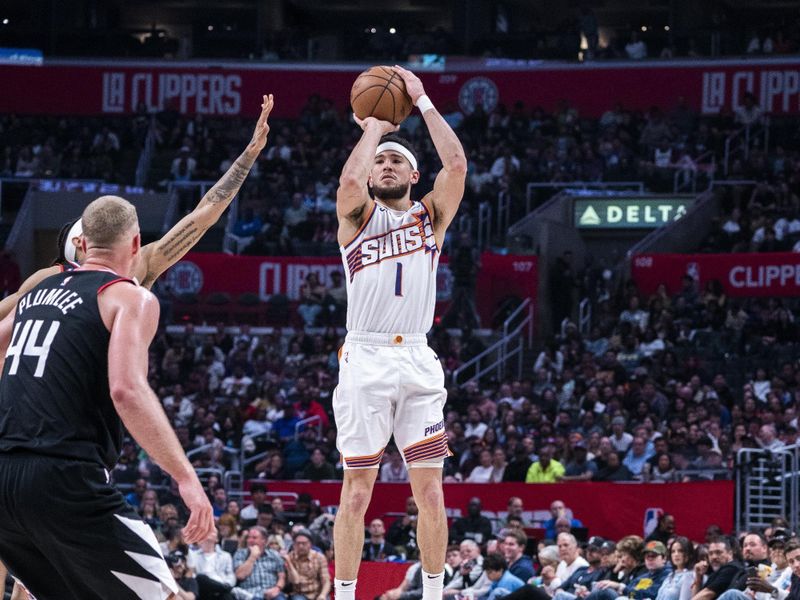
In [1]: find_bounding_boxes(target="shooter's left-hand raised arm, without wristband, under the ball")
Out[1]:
[336,117,397,242]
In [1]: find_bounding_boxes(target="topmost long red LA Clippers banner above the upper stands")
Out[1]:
[7,57,800,118]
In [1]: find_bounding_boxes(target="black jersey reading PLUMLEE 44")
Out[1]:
[0,270,130,468]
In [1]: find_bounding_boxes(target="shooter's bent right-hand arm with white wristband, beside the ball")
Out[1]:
[394,66,467,237]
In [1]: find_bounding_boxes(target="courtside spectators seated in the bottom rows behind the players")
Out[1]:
[86,466,800,600]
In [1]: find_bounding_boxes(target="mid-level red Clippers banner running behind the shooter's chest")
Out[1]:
[164,252,538,327]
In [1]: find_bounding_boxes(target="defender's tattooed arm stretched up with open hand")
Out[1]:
[136,94,274,288]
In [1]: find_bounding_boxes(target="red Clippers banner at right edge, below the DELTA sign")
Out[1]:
[631,252,800,297]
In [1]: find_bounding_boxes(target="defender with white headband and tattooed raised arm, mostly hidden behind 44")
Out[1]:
[0,94,274,319]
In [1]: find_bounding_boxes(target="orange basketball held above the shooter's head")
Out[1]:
[350,67,414,125]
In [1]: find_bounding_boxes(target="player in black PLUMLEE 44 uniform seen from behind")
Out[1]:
[0,196,214,600]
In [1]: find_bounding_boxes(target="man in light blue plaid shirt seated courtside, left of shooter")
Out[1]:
[231,526,286,600]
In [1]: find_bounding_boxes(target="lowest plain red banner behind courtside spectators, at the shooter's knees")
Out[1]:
[267,481,734,541]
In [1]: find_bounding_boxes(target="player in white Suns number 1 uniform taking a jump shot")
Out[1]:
[333,67,467,600]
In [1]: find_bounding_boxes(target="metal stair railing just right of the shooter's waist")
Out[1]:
[451,298,533,386]
